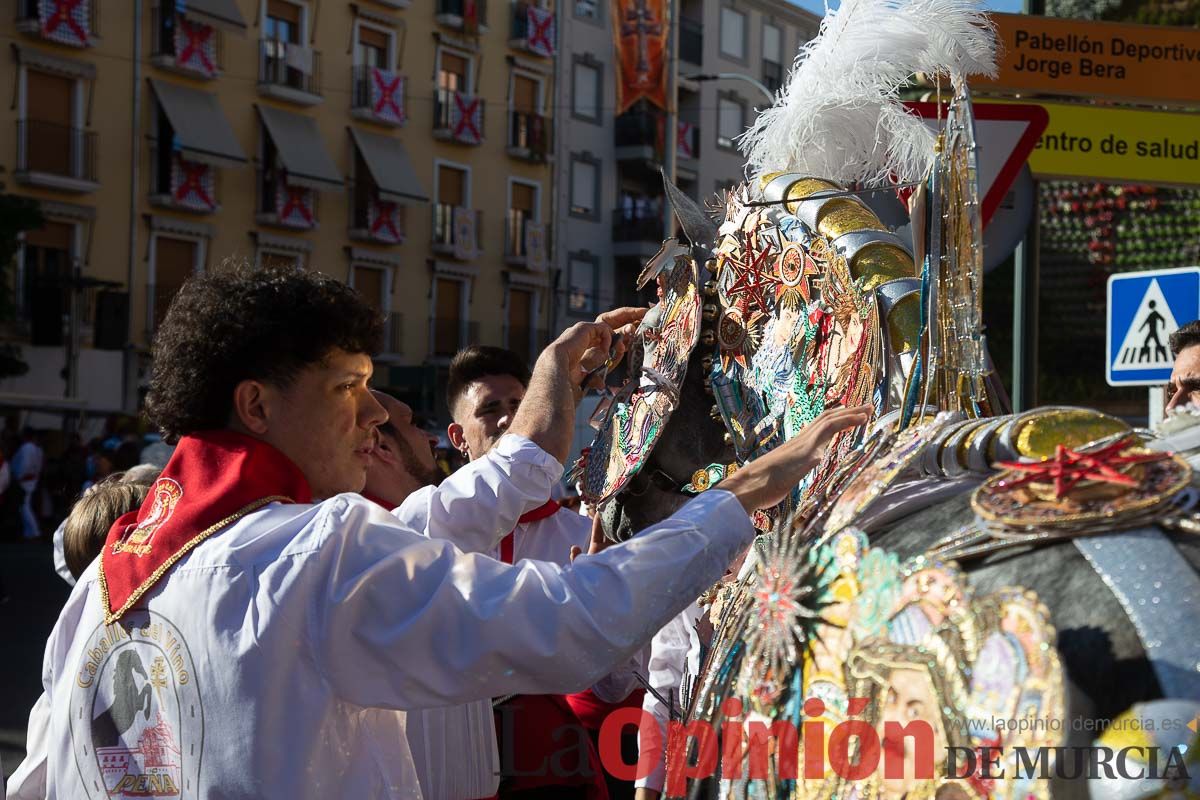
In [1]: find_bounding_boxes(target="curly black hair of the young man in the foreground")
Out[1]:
[146,264,384,443]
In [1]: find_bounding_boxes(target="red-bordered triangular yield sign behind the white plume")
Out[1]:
[905,102,1049,227]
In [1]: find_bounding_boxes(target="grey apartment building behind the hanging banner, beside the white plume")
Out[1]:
[554,0,820,330]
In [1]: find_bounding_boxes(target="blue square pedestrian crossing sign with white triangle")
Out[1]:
[1105,266,1200,386]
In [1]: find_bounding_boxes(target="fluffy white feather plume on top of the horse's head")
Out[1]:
[739,0,996,186]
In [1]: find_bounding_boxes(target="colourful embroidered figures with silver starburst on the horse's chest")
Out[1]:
[690,529,1064,800]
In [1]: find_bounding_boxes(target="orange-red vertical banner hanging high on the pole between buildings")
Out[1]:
[611,0,671,114]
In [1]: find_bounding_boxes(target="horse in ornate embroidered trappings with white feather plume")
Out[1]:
[578,0,1200,800]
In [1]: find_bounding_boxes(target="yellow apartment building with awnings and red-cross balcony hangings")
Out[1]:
[0,0,558,424]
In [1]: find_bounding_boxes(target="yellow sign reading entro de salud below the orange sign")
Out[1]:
[979,100,1200,186]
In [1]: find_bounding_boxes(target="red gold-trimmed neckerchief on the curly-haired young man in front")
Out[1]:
[100,431,312,625]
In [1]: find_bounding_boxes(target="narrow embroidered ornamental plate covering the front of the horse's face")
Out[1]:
[575,239,701,505]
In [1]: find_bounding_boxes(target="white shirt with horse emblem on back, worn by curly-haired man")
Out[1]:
[8,445,754,800]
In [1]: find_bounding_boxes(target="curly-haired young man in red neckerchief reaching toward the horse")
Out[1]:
[8,269,866,800]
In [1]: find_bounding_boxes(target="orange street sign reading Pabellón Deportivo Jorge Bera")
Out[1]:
[971,14,1200,104]
